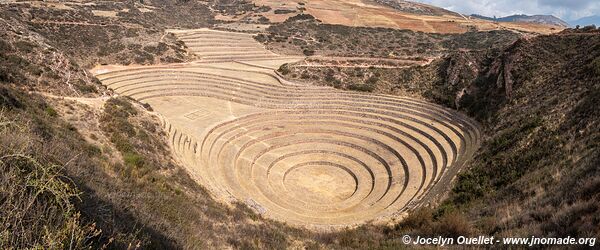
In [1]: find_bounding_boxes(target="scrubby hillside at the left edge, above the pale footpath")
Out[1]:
[0,16,103,96]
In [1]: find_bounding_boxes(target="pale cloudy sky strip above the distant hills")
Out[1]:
[414,0,600,21]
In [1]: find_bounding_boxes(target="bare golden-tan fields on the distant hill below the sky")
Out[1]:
[223,0,562,34]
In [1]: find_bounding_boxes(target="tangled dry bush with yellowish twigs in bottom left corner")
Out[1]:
[0,111,100,249]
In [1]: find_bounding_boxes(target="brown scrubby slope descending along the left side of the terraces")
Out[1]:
[0,4,482,249]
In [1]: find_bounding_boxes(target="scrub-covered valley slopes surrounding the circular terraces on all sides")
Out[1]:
[0,0,600,249]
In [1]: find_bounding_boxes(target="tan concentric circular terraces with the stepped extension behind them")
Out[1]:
[95,29,480,228]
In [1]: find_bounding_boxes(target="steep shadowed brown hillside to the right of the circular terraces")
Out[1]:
[286,29,600,242]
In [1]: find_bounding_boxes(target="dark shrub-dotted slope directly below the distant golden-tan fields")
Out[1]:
[256,14,519,58]
